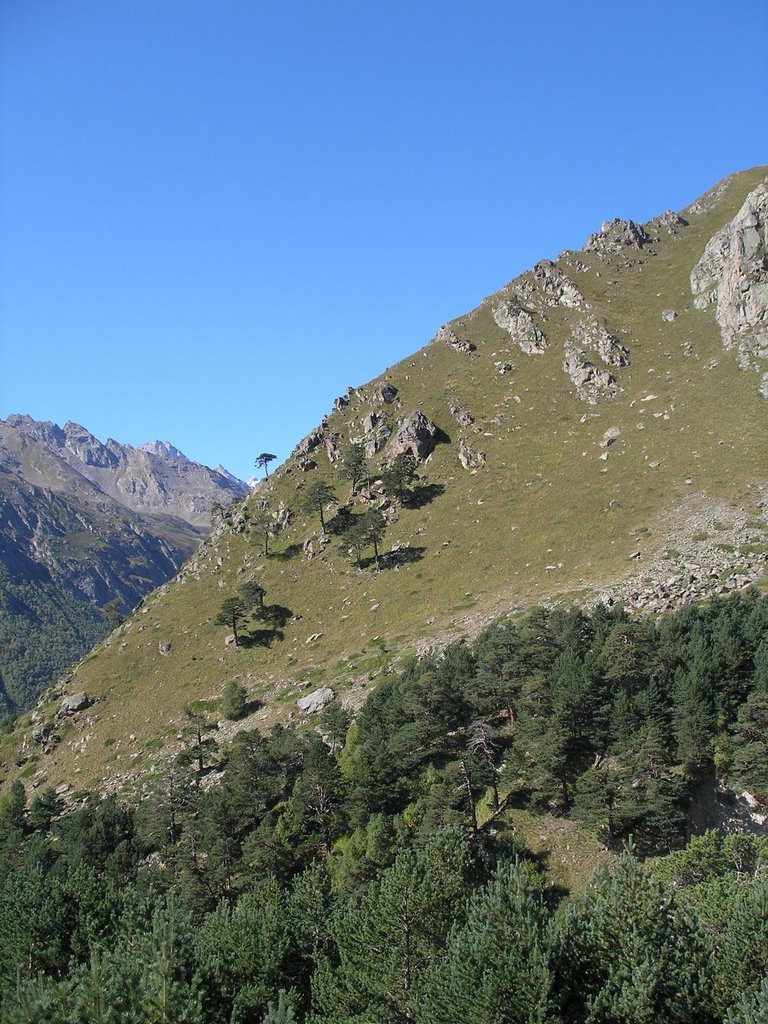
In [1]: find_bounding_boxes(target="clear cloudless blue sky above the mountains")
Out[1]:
[0,0,768,476]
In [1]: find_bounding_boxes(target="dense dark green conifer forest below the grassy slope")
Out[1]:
[0,591,768,1024]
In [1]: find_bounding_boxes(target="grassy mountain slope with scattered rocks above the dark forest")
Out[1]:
[7,168,768,786]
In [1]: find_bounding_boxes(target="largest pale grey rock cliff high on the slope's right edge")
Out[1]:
[690,179,768,369]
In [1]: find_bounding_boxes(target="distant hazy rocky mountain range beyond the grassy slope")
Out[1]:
[0,416,248,708]
